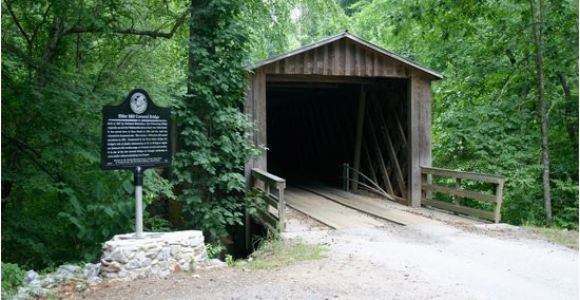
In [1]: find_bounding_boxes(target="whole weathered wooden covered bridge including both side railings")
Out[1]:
[245,32,503,238]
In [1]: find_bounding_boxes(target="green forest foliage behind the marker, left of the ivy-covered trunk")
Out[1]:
[2,0,181,269]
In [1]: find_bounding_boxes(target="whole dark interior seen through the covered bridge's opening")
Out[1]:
[266,79,407,197]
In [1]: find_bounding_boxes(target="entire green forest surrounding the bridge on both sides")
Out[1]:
[2,0,579,269]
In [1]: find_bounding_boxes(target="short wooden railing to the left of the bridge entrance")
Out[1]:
[250,168,286,232]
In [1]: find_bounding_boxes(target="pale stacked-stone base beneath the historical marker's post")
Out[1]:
[100,230,209,280]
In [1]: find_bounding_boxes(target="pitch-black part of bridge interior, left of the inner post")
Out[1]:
[266,84,360,185]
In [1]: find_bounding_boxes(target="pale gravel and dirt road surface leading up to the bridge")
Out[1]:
[70,212,578,300]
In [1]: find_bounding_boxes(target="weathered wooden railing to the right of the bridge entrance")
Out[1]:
[421,167,505,223]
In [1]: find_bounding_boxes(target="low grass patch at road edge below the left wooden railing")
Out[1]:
[235,240,328,270]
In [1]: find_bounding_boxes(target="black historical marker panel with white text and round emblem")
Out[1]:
[101,89,171,170]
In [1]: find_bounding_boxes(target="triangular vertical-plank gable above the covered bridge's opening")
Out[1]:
[259,39,412,78]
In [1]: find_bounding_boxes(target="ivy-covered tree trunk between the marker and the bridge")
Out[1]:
[174,1,258,241]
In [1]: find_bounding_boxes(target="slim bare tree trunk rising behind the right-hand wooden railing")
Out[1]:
[530,0,552,224]
